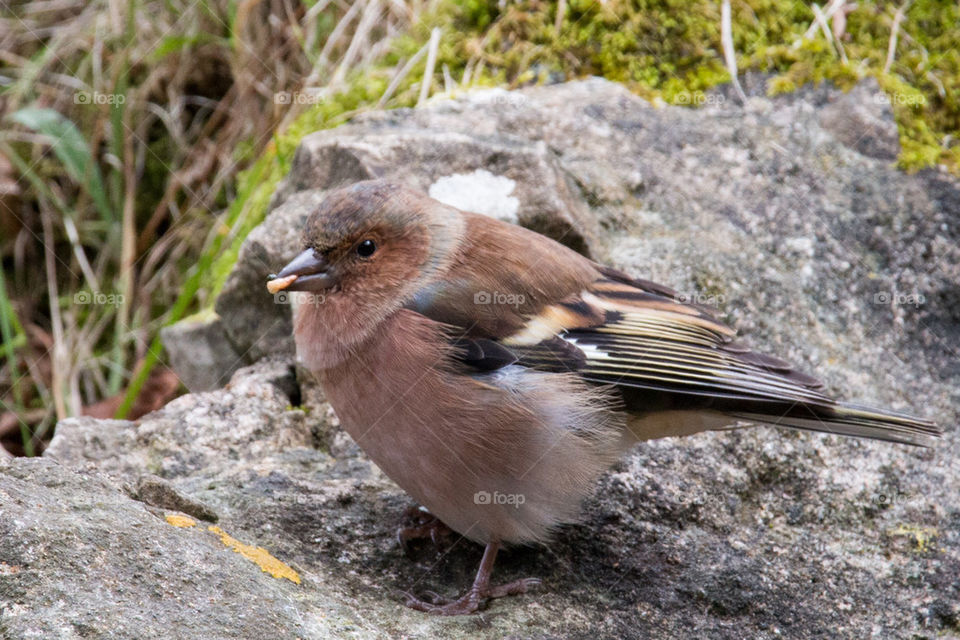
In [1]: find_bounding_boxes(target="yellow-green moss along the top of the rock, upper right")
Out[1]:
[392,0,960,171]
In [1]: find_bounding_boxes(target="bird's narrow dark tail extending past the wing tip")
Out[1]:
[728,403,943,447]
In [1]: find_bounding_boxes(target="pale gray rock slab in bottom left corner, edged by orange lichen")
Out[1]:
[0,459,341,638]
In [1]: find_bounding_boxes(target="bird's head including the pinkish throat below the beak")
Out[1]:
[267,180,465,370]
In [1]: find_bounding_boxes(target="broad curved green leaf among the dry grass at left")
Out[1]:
[10,107,117,223]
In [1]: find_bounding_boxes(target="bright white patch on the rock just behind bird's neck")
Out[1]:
[429,169,520,224]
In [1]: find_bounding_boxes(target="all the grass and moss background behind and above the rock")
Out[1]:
[0,0,960,455]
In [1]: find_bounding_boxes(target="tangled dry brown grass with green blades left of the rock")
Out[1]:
[0,0,417,454]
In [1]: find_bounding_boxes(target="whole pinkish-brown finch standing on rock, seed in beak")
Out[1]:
[267,179,941,615]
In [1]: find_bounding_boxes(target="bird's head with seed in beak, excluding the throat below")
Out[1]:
[267,180,462,306]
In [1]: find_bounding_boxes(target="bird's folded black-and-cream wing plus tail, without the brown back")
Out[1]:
[432,266,940,445]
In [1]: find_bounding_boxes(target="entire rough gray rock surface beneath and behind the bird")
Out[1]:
[0,80,960,638]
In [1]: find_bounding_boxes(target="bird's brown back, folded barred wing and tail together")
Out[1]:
[407,214,939,444]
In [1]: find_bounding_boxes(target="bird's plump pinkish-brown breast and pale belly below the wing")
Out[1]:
[318,310,620,542]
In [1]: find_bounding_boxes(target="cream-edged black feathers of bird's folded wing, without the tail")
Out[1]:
[501,269,831,410]
